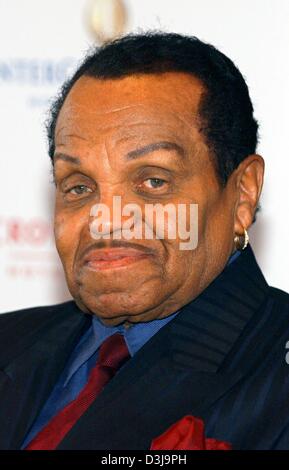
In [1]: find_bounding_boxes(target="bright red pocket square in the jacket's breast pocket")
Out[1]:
[150,416,232,450]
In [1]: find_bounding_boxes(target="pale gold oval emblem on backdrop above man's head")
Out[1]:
[87,0,127,43]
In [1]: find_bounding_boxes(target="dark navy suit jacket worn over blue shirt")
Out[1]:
[0,246,289,450]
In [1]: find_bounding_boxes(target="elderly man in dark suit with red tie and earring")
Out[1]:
[0,33,289,450]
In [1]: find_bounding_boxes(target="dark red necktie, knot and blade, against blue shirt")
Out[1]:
[25,333,129,450]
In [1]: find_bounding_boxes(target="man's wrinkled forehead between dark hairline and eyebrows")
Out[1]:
[55,72,204,145]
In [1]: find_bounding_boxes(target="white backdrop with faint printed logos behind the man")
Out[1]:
[0,0,289,312]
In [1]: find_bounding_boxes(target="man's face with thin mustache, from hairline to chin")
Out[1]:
[54,73,235,325]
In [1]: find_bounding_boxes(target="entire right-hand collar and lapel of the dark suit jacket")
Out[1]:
[58,247,268,450]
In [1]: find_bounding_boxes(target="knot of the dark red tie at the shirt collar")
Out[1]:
[98,333,130,370]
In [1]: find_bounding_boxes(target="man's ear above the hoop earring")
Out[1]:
[234,154,265,235]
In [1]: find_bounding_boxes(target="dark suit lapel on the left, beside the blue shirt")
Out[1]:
[0,302,90,449]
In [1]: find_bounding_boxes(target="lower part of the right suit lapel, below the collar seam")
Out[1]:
[58,322,233,450]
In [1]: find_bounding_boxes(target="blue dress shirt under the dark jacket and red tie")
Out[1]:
[21,251,240,449]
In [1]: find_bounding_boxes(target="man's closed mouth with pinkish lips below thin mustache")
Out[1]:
[84,248,152,271]
